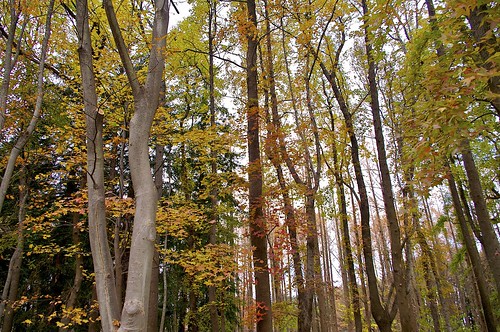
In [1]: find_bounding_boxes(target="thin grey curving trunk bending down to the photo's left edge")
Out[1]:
[0,0,54,212]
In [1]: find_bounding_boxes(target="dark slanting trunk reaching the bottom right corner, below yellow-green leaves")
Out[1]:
[448,166,497,331]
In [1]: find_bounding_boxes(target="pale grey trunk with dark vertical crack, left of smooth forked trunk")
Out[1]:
[76,0,120,331]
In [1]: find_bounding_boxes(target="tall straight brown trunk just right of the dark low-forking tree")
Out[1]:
[361,0,417,332]
